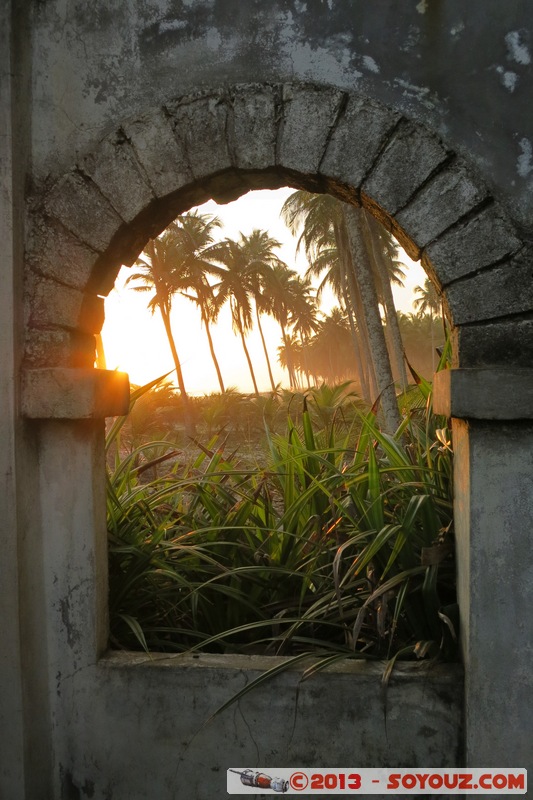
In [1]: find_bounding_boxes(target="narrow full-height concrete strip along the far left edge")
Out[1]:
[0,0,31,800]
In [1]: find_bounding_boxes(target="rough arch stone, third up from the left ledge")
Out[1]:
[26,216,99,291]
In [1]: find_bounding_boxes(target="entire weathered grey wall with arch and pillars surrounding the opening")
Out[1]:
[0,0,533,800]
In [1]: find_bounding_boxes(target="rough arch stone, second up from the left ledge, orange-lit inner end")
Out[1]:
[30,278,104,333]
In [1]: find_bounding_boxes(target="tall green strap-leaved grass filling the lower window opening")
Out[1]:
[108,372,456,664]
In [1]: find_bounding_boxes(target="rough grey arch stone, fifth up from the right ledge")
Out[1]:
[362,122,448,214]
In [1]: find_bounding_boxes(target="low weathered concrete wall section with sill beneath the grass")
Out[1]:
[60,653,463,800]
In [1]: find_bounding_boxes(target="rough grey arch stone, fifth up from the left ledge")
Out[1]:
[79,133,154,222]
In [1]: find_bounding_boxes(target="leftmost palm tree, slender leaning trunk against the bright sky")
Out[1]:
[126,232,194,431]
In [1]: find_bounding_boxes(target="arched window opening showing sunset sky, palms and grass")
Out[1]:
[102,187,456,661]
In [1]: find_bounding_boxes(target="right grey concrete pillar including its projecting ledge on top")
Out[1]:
[434,369,533,774]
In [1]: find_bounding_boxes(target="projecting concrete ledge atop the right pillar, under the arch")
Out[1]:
[433,367,533,420]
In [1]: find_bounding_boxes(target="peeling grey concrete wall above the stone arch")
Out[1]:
[33,0,533,231]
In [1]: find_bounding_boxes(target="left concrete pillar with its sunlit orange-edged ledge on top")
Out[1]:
[17,369,129,800]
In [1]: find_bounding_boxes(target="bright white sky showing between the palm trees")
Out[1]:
[102,188,426,395]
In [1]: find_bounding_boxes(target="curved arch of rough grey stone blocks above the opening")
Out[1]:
[22,84,533,382]
